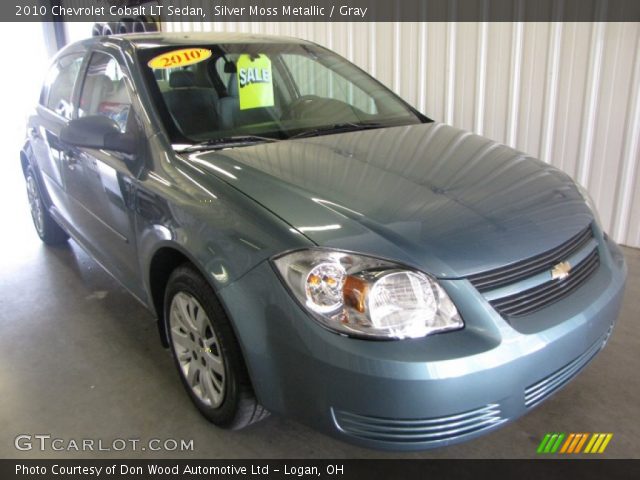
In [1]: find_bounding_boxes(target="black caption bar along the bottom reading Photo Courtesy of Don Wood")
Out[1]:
[0,459,640,480]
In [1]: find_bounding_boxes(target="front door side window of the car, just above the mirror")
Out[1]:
[78,52,133,133]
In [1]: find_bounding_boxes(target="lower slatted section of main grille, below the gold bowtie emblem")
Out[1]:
[490,248,600,317]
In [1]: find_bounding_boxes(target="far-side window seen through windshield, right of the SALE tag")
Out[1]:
[282,53,377,114]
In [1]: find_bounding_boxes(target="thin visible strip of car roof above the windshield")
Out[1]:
[75,32,311,50]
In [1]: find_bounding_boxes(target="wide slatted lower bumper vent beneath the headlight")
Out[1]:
[332,404,505,443]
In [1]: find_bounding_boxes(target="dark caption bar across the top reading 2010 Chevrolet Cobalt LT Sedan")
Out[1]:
[7,0,640,22]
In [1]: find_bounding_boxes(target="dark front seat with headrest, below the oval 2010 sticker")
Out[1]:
[163,70,220,137]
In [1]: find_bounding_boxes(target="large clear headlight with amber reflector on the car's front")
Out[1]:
[274,249,464,338]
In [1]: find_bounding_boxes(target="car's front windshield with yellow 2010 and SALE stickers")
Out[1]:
[138,43,428,146]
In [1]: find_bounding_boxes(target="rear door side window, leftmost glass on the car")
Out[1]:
[40,55,83,119]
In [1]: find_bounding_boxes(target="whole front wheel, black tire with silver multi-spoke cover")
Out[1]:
[164,265,268,429]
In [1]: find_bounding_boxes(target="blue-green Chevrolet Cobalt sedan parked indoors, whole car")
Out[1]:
[20,34,626,449]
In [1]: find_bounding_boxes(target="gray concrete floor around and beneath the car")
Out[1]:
[0,158,640,458]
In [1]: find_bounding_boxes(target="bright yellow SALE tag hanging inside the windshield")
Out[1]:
[237,54,273,110]
